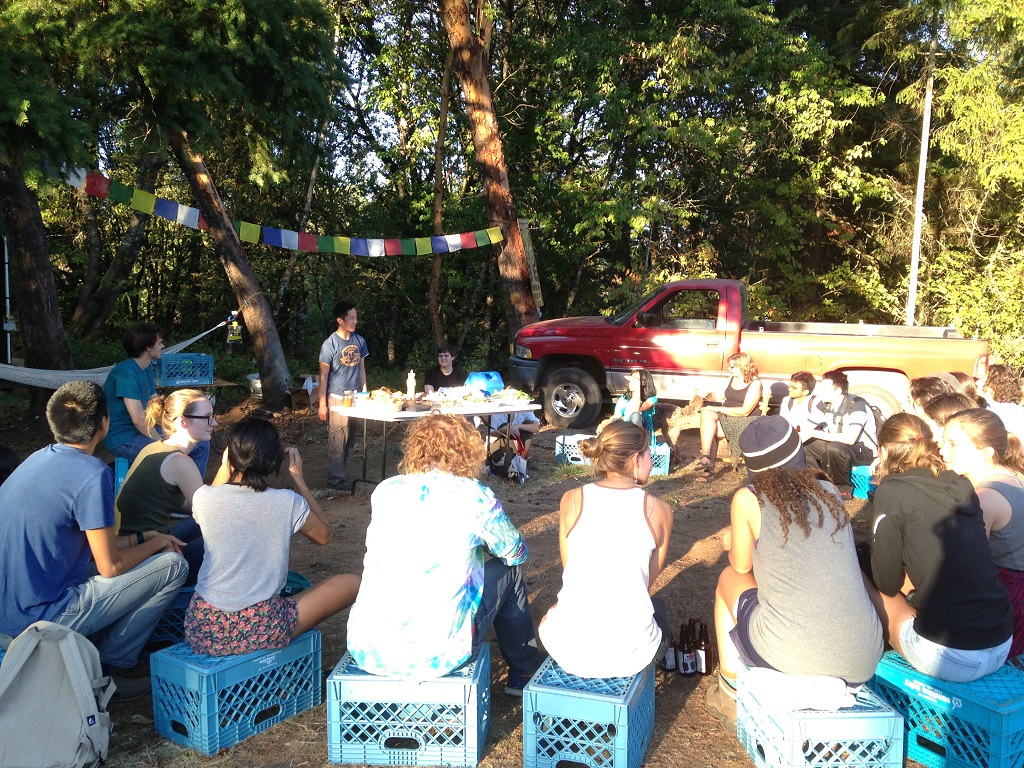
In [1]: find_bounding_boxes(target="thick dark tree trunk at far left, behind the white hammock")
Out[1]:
[0,150,71,410]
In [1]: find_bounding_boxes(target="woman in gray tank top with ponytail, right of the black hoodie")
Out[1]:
[942,408,1024,656]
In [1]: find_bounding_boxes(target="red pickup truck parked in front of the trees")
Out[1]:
[509,280,988,427]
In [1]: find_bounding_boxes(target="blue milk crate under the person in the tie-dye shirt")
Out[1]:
[327,644,490,766]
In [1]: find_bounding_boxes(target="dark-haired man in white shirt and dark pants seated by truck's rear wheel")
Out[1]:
[801,371,879,498]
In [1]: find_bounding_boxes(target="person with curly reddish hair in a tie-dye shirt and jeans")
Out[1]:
[348,414,544,696]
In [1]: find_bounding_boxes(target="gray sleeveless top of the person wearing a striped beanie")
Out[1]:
[750,482,882,685]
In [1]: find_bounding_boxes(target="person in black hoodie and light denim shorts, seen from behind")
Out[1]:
[871,414,1013,682]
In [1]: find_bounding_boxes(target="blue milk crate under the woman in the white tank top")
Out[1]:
[522,657,654,768]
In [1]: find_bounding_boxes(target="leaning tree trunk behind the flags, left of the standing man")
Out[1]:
[165,131,292,409]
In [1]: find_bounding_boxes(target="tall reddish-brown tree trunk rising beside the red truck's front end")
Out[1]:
[440,0,540,348]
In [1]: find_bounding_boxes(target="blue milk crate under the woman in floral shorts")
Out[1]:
[150,630,321,755]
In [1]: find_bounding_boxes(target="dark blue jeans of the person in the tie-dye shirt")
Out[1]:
[473,558,544,688]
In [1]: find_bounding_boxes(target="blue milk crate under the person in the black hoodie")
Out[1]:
[868,651,1024,768]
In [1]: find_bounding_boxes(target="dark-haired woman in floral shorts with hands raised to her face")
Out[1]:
[184,417,359,656]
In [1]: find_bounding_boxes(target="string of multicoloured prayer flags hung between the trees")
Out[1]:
[63,168,504,258]
